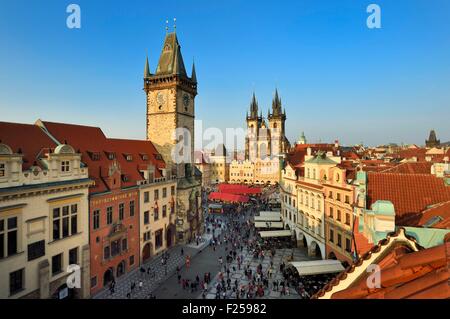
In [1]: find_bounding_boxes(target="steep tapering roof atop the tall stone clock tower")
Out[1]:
[156,32,188,77]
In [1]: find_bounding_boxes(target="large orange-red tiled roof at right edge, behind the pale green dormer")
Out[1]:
[367,173,450,222]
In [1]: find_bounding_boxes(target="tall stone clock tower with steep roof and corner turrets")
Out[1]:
[144,32,203,242]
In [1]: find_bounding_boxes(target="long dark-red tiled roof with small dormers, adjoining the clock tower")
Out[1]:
[43,122,165,193]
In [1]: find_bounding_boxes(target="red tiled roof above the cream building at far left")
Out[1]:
[0,122,57,170]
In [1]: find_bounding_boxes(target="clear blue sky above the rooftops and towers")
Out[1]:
[0,0,450,150]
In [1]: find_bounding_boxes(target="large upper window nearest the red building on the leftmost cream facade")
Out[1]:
[52,204,78,240]
